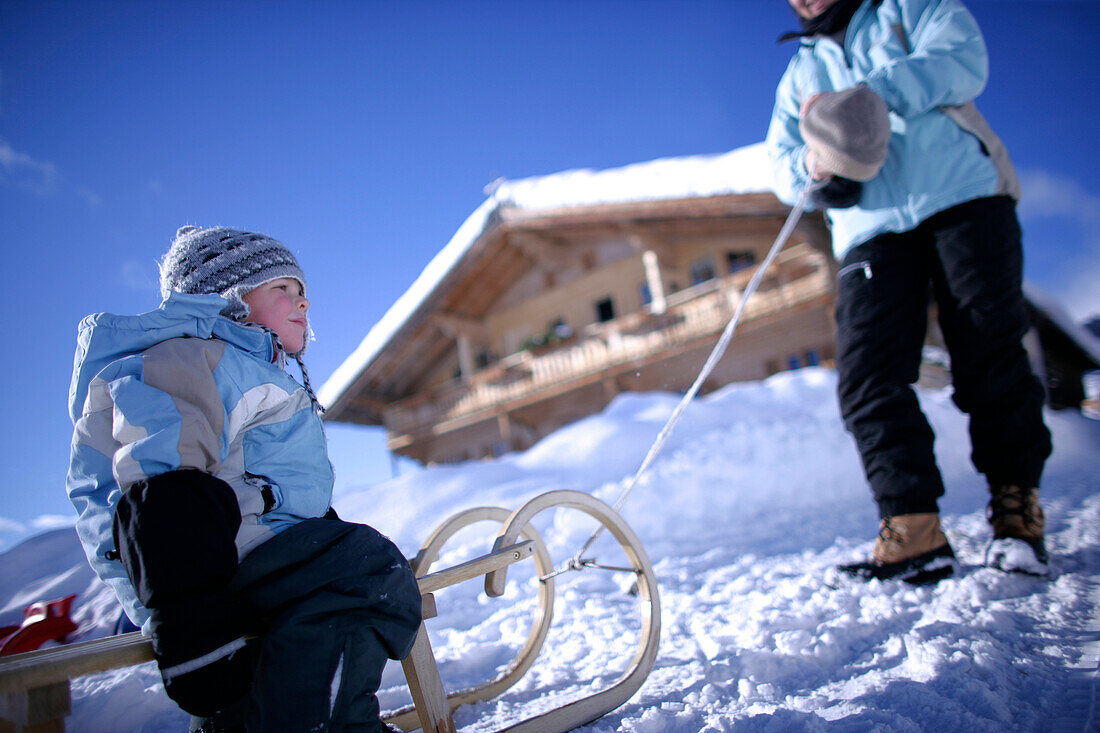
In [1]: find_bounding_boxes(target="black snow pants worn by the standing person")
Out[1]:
[836,196,1051,517]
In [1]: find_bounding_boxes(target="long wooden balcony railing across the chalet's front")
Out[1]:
[385,244,832,434]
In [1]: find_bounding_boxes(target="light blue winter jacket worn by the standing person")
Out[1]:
[767,0,1007,260]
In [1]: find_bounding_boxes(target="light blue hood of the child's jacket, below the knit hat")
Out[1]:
[69,293,279,424]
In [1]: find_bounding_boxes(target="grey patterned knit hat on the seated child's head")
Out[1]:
[161,227,306,320]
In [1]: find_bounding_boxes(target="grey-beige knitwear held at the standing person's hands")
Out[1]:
[799,85,890,180]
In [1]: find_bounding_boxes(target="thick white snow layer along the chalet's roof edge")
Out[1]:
[318,143,771,407]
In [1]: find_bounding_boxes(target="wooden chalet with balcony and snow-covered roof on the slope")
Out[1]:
[320,145,835,463]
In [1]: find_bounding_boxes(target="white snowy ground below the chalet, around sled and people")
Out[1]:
[0,369,1100,733]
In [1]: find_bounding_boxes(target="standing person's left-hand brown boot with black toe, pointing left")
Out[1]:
[839,513,955,586]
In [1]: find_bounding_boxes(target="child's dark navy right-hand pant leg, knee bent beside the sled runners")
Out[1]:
[195,518,420,733]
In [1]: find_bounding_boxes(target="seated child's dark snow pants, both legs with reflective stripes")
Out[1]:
[114,470,421,733]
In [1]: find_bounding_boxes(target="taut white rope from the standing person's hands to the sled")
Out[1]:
[551,182,825,575]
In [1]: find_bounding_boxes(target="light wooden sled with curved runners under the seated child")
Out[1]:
[0,491,661,733]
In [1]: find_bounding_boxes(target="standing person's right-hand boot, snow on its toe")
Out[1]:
[986,484,1047,575]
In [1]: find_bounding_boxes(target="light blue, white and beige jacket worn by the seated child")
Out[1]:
[66,293,332,625]
